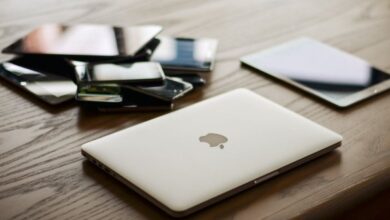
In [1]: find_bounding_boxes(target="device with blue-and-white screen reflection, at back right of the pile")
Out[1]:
[151,37,218,71]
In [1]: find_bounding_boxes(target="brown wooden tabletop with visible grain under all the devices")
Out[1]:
[0,0,390,219]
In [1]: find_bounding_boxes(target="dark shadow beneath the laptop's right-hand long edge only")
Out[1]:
[191,150,341,219]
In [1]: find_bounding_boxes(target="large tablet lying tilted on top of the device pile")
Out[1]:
[3,24,162,58]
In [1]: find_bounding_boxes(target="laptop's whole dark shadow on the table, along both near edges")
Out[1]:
[83,150,341,219]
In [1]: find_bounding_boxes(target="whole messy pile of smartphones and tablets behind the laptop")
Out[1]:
[0,25,217,111]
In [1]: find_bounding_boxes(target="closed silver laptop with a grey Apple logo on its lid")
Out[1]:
[81,89,342,216]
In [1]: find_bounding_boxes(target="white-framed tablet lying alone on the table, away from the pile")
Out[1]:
[241,38,390,107]
